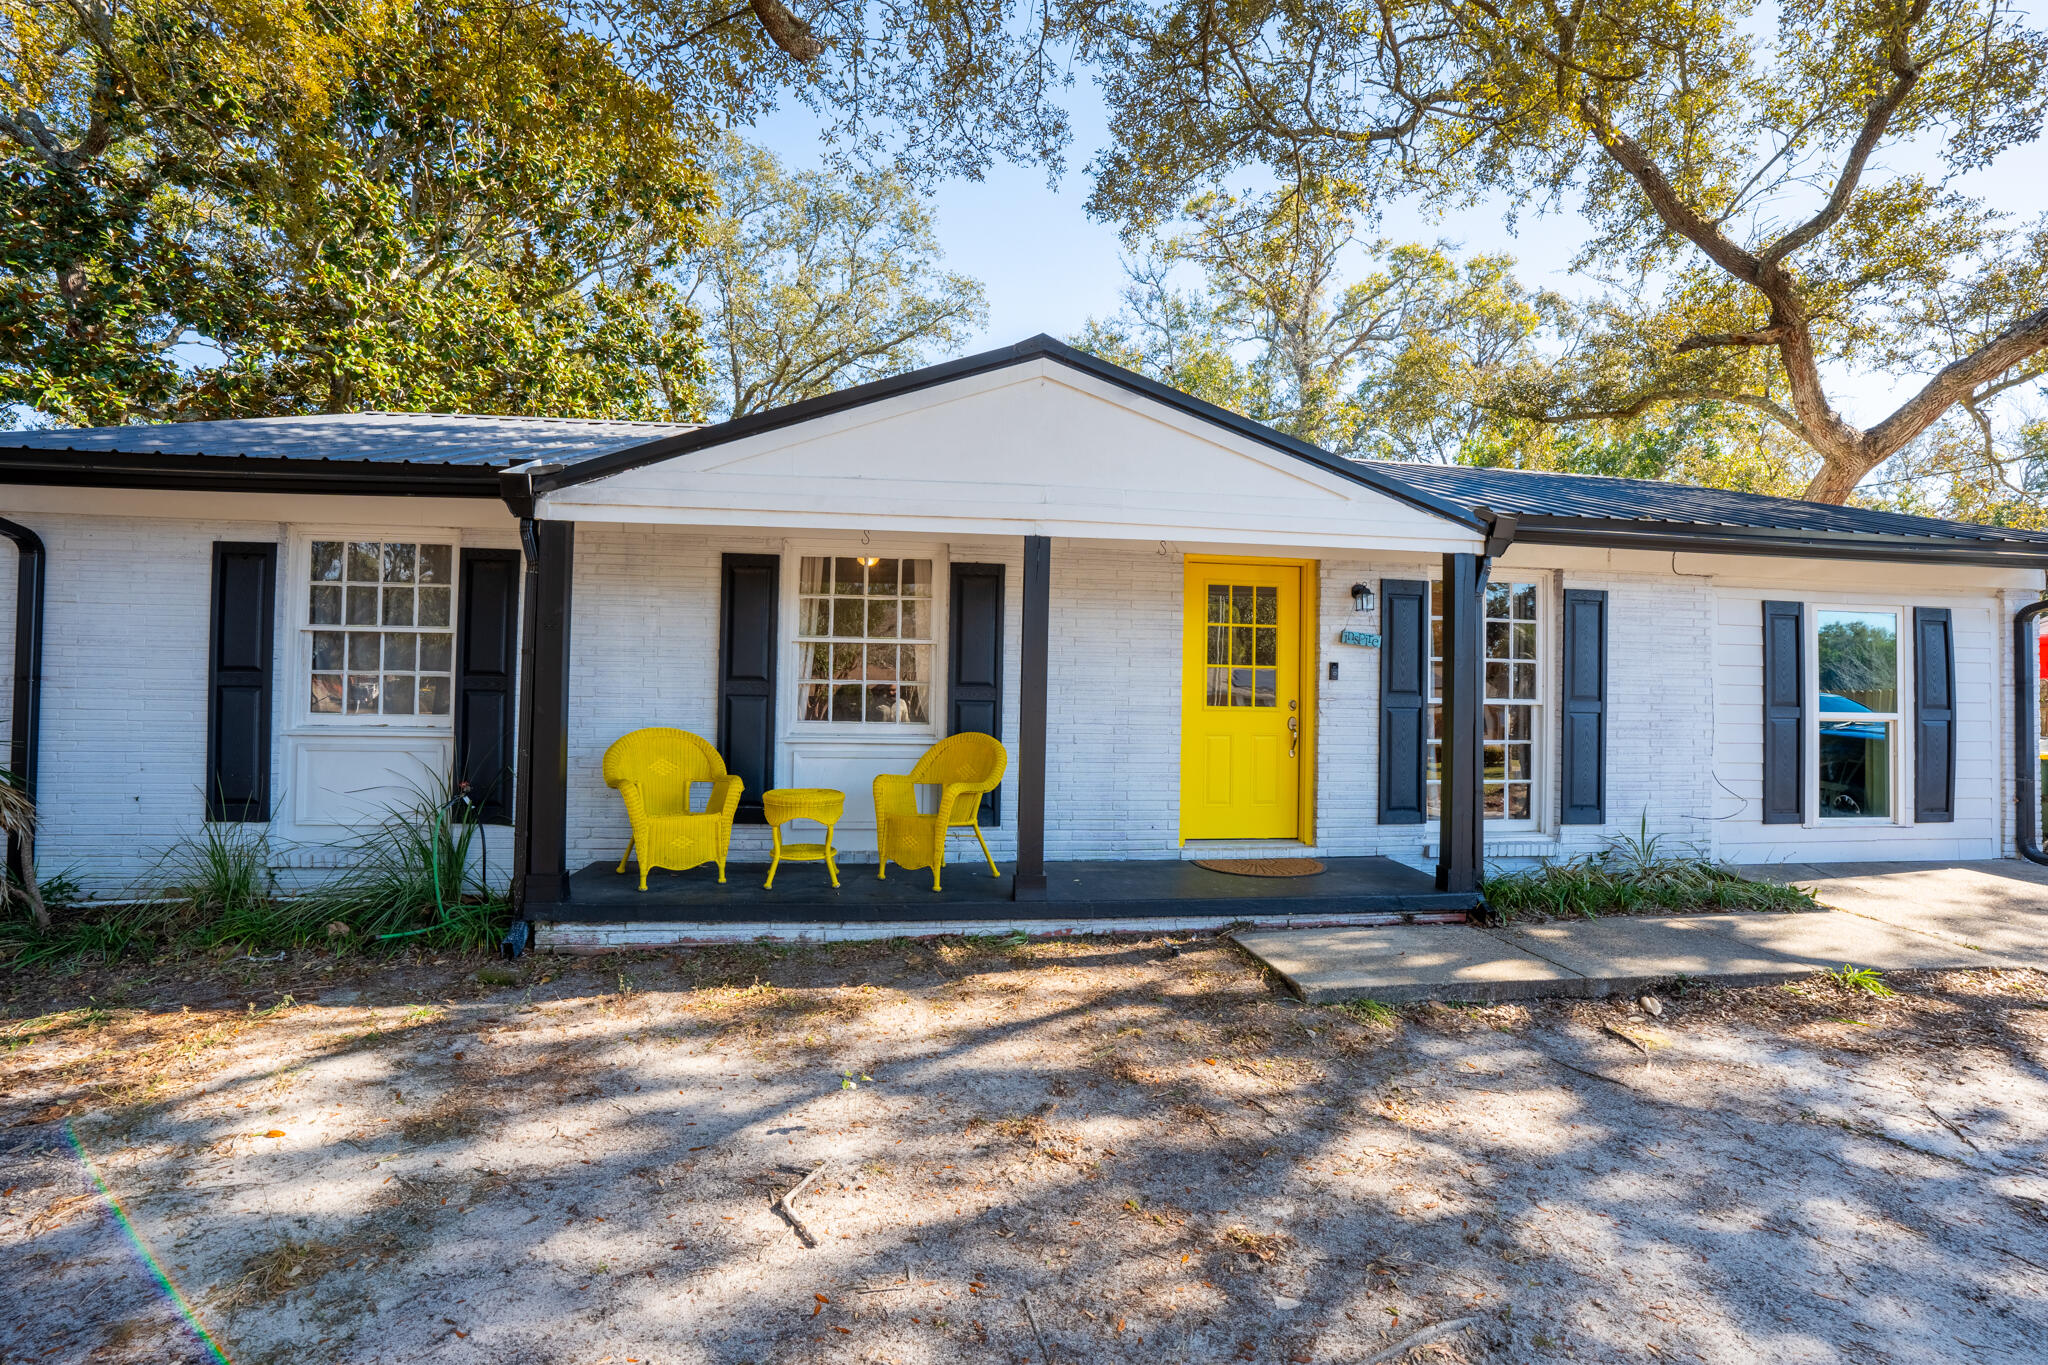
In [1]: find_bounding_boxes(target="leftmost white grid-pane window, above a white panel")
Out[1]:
[305,540,455,720]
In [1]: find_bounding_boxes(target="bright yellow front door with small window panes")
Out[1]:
[1180,561,1307,839]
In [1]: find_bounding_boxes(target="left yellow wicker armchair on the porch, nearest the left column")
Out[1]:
[604,729,745,890]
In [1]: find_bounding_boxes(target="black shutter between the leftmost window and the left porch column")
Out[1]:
[455,551,522,825]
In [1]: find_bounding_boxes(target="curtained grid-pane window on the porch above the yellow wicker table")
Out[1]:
[797,555,934,724]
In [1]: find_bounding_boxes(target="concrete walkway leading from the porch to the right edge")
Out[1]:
[1237,862,2048,1005]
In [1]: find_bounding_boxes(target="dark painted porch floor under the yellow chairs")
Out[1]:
[526,857,1479,925]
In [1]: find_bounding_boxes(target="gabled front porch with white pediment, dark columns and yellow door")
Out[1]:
[506,349,1499,941]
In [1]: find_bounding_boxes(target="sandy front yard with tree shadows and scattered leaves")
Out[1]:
[0,937,2048,1365]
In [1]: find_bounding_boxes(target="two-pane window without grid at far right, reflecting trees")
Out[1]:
[1815,612,1898,821]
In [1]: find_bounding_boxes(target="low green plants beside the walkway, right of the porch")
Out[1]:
[1481,821,1815,923]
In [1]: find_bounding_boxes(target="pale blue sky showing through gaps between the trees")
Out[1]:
[748,78,2048,422]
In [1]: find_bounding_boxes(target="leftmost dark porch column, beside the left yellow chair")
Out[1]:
[512,520,575,915]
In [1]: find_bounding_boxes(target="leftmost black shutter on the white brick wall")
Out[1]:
[207,540,276,823]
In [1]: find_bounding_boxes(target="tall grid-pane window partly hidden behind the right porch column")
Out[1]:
[1427,583,1540,821]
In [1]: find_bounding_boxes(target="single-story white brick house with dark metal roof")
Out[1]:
[0,338,2048,945]
